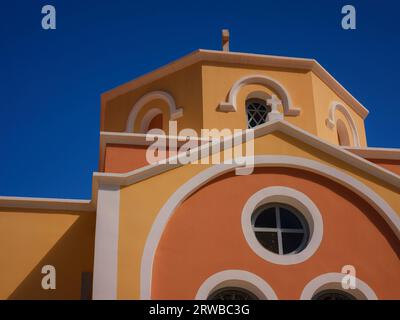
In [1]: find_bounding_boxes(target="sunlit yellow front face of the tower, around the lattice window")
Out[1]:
[203,64,317,134]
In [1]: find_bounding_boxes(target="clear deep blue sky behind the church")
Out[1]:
[0,0,400,199]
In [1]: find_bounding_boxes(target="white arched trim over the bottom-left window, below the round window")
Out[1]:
[195,270,278,300]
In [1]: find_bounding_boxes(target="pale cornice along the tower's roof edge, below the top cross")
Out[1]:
[102,49,369,119]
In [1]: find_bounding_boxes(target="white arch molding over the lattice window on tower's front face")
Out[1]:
[219,75,301,116]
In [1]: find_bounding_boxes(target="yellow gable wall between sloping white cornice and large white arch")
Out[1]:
[118,132,400,299]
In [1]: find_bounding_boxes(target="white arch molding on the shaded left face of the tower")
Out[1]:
[125,91,183,133]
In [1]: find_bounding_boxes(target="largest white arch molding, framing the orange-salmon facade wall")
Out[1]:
[140,155,400,300]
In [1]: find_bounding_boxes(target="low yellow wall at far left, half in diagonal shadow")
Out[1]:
[0,209,96,299]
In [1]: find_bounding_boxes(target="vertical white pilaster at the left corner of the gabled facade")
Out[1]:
[93,185,120,300]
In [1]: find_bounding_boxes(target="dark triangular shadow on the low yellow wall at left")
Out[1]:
[8,212,95,300]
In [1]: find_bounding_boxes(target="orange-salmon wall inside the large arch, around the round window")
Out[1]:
[152,168,400,299]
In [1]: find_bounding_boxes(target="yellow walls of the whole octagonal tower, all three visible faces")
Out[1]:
[104,61,367,146]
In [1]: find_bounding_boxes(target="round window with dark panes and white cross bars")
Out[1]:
[252,203,309,255]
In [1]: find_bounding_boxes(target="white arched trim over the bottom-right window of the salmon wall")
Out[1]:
[300,273,378,300]
